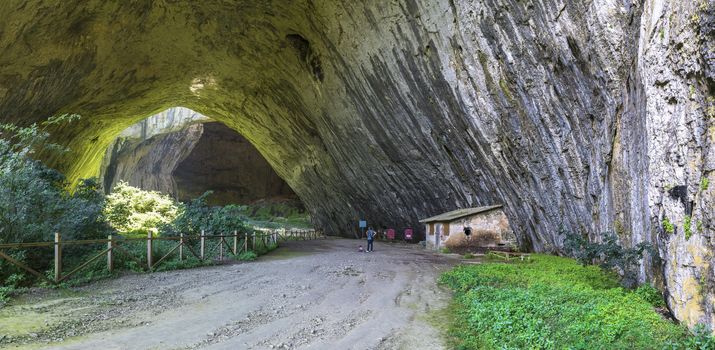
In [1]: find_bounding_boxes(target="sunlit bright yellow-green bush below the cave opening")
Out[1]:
[104,182,179,236]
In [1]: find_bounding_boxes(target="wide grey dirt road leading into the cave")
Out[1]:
[0,239,457,349]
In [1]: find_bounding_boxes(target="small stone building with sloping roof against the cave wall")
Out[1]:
[420,205,516,249]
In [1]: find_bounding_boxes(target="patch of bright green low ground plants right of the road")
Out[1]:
[440,255,708,349]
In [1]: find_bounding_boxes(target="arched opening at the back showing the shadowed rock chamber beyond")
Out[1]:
[100,107,305,219]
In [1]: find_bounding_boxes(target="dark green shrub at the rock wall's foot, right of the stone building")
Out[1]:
[560,229,655,288]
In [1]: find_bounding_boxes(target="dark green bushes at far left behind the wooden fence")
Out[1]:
[0,115,111,286]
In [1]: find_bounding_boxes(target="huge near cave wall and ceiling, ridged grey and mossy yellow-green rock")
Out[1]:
[0,0,715,326]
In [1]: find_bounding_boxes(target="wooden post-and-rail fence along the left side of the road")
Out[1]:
[0,229,325,284]
